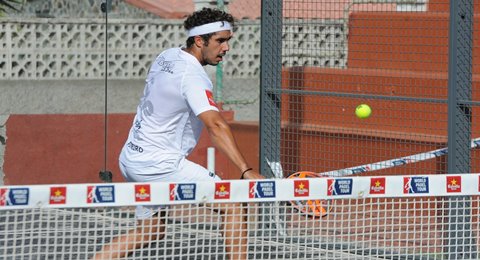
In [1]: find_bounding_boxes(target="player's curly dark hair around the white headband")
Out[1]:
[183,7,235,47]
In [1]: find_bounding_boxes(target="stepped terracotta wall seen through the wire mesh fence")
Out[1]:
[282,0,480,174]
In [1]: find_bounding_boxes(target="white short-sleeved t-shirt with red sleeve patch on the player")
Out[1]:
[120,48,218,174]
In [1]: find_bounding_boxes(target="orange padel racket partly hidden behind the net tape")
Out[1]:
[287,171,333,217]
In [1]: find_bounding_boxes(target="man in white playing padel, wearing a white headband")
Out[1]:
[94,8,263,259]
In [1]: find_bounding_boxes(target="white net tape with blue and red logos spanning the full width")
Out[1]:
[0,173,480,210]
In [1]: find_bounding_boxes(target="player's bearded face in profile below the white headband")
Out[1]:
[203,31,233,65]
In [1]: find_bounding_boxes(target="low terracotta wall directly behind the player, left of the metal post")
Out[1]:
[3,112,258,185]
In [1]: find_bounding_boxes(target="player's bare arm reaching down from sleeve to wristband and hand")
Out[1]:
[198,110,264,179]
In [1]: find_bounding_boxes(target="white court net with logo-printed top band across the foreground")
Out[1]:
[0,174,480,259]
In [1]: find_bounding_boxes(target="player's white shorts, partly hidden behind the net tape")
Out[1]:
[119,158,221,219]
